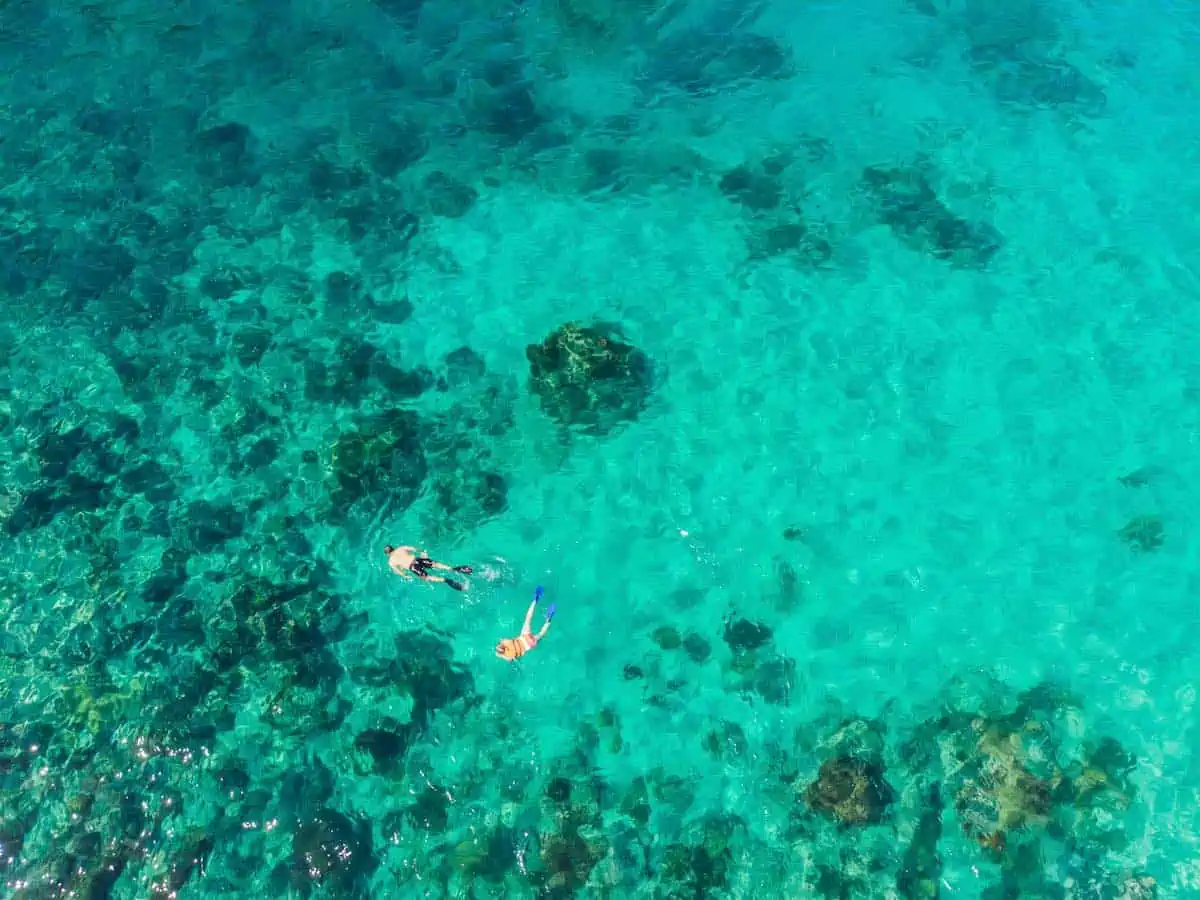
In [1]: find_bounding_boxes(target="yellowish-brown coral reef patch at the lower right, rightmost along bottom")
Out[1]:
[899,684,1153,896]
